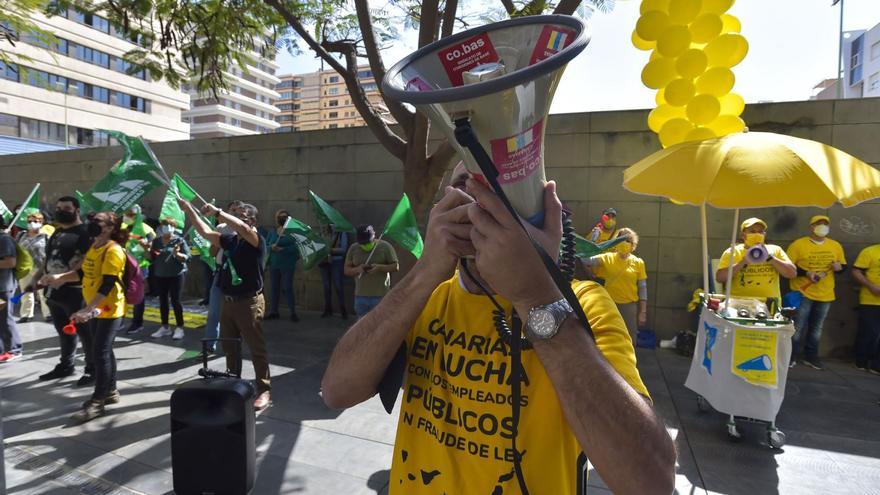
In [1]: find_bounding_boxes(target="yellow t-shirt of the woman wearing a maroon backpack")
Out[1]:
[82,241,125,319]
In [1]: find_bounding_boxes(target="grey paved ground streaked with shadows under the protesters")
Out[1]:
[0,313,880,495]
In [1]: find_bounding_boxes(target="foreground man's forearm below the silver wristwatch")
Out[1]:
[520,314,675,495]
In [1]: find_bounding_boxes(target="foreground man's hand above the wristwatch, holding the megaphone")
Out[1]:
[467,179,562,310]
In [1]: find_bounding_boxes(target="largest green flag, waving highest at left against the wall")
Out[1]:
[84,131,168,213]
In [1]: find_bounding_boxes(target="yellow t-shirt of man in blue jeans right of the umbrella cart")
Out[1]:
[786,237,846,302]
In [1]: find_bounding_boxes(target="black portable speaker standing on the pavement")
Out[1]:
[171,340,256,495]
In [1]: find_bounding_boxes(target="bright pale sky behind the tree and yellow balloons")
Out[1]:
[278,0,880,113]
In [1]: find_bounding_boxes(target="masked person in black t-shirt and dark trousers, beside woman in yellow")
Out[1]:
[33,196,95,387]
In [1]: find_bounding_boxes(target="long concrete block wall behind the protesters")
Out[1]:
[0,99,880,360]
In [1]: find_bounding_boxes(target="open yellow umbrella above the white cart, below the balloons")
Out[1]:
[623,132,880,208]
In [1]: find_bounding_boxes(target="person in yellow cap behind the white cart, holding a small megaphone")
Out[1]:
[715,218,797,300]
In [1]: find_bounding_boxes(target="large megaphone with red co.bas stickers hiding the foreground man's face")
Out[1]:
[382,15,589,223]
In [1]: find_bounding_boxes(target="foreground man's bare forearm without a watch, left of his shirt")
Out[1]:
[321,263,437,409]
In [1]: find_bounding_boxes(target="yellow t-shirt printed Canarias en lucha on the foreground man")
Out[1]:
[389,274,648,495]
